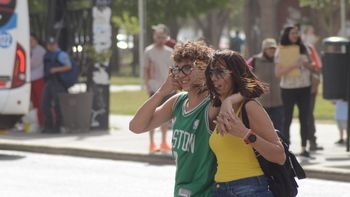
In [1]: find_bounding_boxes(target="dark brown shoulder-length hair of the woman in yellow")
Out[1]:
[205,49,268,107]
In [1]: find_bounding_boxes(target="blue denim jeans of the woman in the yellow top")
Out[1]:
[214,175,273,197]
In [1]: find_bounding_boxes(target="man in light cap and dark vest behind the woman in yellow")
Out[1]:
[247,38,284,132]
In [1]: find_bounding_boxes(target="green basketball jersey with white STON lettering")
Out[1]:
[172,93,216,197]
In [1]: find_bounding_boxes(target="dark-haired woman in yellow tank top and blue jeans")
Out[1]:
[206,50,285,197]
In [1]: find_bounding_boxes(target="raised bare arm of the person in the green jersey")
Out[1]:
[129,75,179,133]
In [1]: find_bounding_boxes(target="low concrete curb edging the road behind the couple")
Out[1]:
[0,142,350,182]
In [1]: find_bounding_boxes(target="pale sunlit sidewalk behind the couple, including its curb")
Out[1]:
[0,115,350,182]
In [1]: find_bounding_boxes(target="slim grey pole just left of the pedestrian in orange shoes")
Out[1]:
[138,0,145,86]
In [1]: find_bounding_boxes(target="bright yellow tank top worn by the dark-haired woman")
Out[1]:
[209,103,263,182]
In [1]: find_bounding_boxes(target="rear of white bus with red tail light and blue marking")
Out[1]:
[0,0,30,128]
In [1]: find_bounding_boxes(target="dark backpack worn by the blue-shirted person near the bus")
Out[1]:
[56,51,80,89]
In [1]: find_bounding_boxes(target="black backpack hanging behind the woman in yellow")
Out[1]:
[242,100,306,197]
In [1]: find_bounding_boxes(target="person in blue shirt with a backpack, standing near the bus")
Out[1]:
[42,37,72,133]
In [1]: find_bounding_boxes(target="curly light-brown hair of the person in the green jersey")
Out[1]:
[172,41,214,94]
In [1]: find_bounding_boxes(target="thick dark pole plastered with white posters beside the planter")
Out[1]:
[88,0,113,130]
